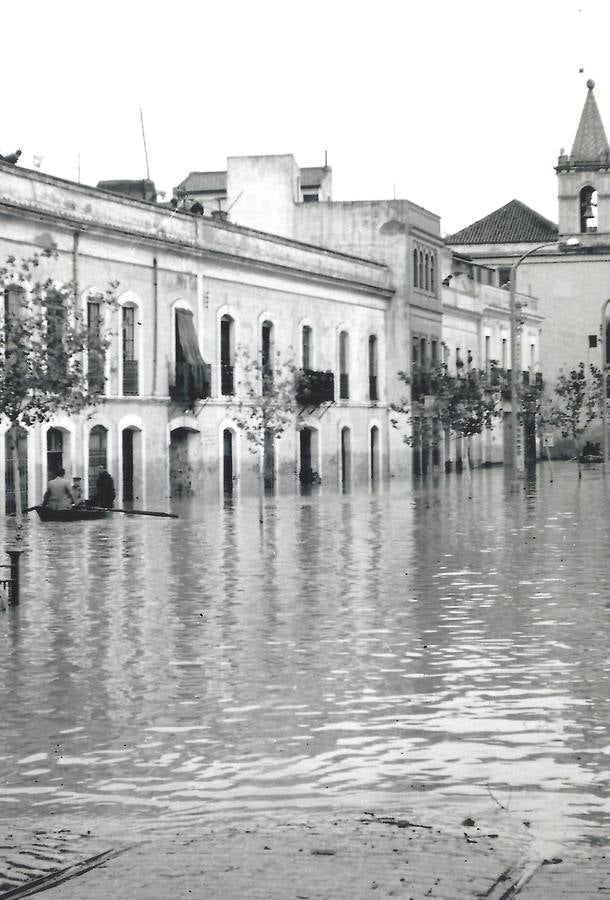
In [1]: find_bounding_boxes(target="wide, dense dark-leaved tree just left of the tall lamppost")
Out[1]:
[390,363,501,468]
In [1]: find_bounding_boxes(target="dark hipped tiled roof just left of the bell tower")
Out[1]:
[445,200,558,244]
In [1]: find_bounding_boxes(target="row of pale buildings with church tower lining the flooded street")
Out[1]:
[0,82,610,511]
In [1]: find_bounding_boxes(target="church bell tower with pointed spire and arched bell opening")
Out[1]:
[555,79,610,237]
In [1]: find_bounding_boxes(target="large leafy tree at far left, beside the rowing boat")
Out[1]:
[0,251,117,523]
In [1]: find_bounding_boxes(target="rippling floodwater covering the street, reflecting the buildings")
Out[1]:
[0,464,610,890]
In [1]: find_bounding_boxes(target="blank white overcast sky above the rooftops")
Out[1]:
[0,0,610,233]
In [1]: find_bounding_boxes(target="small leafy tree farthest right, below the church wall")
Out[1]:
[548,362,602,478]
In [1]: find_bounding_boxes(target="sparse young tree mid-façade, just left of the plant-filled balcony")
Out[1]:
[232,346,298,521]
